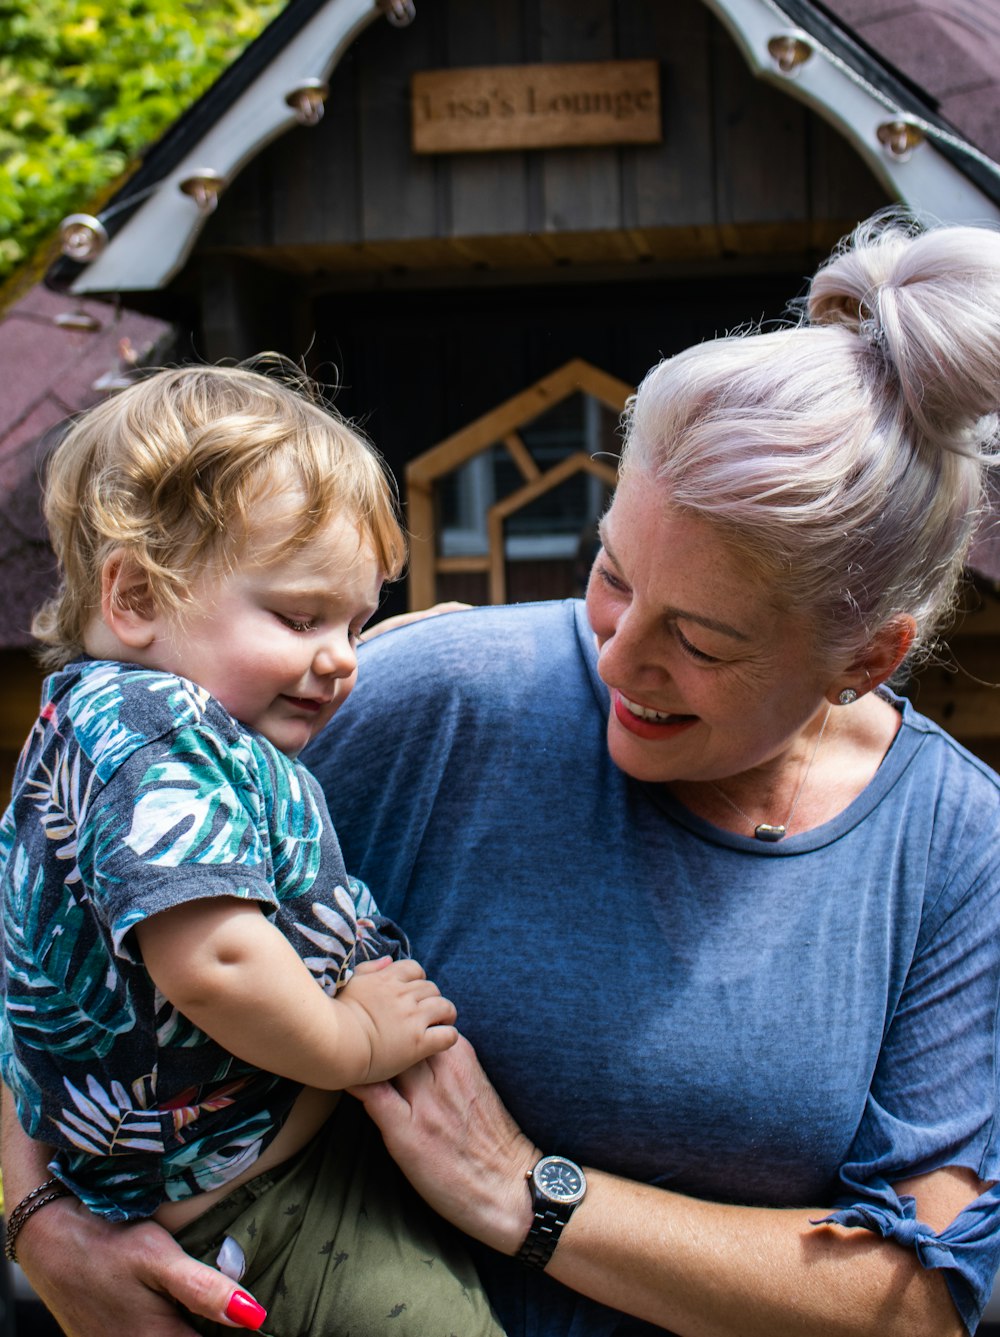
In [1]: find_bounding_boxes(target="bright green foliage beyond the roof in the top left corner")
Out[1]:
[0,0,285,281]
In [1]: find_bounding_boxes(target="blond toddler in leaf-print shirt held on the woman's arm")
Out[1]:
[0,366,499,1337]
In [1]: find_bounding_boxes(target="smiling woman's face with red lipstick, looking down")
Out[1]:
[587,473,834,782]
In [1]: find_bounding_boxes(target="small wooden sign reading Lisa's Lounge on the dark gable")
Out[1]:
[412,60,663,154]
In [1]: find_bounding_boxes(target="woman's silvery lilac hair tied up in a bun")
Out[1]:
[623,214,1000,668]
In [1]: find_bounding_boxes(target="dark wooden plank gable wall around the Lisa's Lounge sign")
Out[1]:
[198,0,886,286]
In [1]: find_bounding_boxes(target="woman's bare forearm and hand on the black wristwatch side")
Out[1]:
[354,1040,981,1337]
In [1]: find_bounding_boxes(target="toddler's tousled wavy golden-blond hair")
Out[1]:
[32,354,406,667]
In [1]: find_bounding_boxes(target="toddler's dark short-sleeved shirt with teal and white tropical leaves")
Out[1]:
[0,660,406,1221]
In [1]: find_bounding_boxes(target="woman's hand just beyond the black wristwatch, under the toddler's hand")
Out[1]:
[352,1036,540,1254]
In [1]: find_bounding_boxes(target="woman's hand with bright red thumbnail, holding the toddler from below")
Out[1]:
[17,1198,265,1337]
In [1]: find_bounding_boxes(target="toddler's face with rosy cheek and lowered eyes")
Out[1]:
[146,516,382,757]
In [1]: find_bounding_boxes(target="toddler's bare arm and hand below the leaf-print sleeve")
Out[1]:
[135,897,457,1091]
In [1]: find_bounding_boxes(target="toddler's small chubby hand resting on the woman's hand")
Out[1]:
[337,959,459,1084]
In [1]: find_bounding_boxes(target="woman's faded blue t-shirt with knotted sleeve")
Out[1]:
[306,602,1000,1337]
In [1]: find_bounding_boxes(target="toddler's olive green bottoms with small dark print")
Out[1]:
[176,1096,503,1337]
